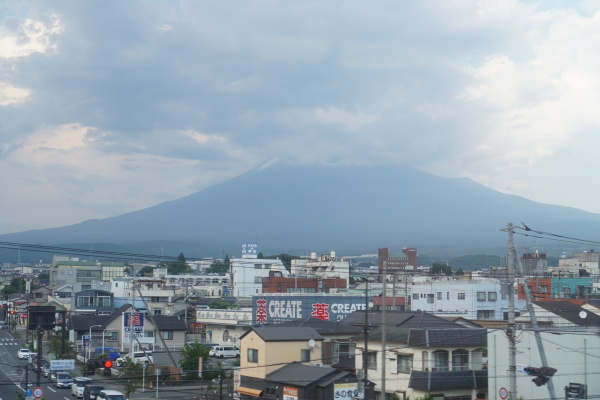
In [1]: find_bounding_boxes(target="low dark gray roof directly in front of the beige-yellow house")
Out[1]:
[265,362,354,387]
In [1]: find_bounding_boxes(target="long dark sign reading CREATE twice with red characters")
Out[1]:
[252,295,366,324]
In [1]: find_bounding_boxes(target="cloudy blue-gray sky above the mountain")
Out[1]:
[0,0,600,233]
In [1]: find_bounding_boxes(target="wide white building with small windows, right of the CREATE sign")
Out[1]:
[409,279,526,320]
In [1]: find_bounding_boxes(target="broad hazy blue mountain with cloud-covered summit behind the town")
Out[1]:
[0,164,600,257]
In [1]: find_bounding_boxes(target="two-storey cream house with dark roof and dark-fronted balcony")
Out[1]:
[355,325,488,400]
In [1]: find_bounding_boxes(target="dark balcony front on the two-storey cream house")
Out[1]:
[408,369,488,392]
